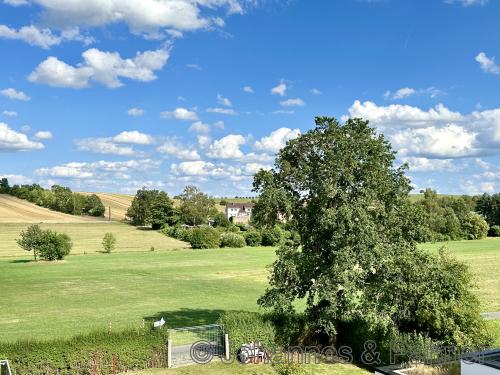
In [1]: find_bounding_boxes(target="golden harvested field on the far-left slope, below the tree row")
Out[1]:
[0,194,102,223]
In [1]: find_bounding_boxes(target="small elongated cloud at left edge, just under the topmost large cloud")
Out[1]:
[0,25,93,49]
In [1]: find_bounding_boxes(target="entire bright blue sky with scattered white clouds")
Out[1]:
[0,0,500,196]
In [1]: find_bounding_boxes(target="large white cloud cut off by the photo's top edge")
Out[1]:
[10,0,255,39]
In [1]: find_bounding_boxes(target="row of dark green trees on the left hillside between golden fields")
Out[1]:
[0,178,105,216]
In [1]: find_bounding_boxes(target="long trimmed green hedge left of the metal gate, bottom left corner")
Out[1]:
[0,328,168,375]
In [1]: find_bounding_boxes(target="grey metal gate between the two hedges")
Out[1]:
[168,324,225,367]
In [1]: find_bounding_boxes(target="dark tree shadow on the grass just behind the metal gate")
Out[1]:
[144,309,242,328]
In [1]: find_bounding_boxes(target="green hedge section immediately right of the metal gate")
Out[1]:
[218,311,276,354]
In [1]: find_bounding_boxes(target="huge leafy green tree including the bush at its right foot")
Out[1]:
[255,117,488,350]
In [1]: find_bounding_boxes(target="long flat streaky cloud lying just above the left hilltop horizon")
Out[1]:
[35,159,162,179]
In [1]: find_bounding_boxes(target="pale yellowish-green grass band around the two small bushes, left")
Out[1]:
[0,222,189,258]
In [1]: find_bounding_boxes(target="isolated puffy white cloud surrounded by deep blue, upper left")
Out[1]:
[28,48,169,88]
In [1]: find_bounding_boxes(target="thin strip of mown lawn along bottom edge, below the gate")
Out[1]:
[121,360,372,375]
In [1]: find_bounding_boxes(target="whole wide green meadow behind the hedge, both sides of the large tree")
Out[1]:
[0,223,500,341]
